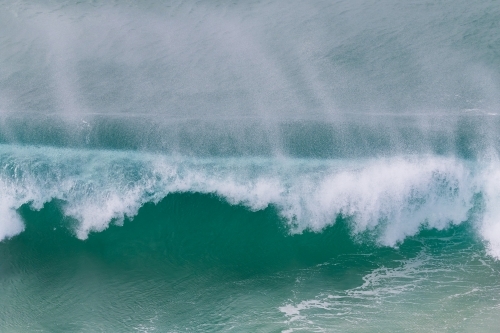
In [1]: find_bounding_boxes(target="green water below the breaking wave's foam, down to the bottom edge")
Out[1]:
[0,194,500,332]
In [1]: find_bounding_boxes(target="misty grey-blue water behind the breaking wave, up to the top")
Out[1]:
[0,1,500,157]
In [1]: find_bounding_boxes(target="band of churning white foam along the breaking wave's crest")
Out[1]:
[0,145,500,258]
